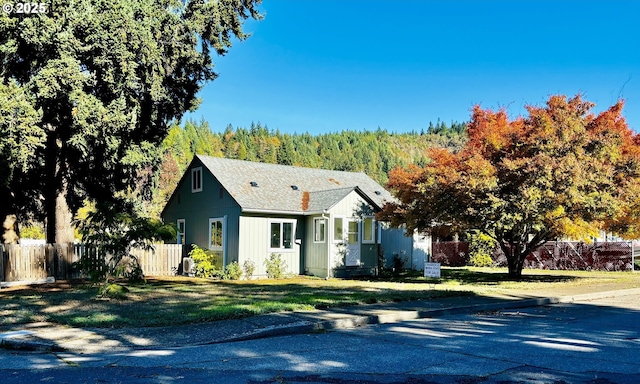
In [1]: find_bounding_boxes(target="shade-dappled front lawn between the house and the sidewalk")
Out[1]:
[0,268,640,327]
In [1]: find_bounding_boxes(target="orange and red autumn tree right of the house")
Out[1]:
[379,95,640,279]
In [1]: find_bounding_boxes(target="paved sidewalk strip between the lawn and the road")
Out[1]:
[0,286,640,354]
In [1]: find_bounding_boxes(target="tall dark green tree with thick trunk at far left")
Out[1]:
[0,0,260,242]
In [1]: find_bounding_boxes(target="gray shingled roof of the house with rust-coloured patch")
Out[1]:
[196,155,394,214]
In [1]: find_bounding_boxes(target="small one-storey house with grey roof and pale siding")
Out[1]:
[162,155,404,277]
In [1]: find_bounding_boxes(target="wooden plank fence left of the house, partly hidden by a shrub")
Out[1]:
[0,243,182,282]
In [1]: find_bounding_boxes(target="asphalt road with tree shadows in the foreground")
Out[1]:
[0,296,640,384]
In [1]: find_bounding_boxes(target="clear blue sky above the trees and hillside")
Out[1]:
[187,0,640,134]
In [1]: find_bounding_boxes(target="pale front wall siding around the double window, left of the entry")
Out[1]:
[238,215,306,278]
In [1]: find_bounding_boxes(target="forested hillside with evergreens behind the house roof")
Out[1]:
[143,120,466,216]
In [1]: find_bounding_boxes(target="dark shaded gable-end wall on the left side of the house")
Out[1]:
[162,159,240,264]
